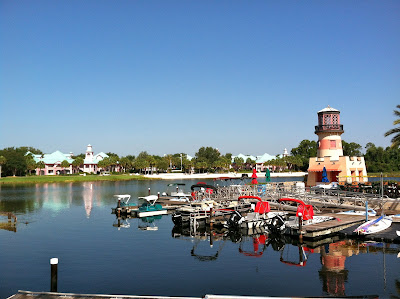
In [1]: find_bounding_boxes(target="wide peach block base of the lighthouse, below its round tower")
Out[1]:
[307,156,368,186]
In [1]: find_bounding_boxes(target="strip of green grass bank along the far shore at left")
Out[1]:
[0,174,152,185]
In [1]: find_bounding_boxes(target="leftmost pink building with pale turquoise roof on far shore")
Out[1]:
[27,151,74,175]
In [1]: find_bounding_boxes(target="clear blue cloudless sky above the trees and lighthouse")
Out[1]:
[0,0,400,156]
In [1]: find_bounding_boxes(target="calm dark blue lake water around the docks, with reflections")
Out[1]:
[0,179,400,298]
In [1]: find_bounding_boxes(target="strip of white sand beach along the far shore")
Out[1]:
[145,172,307,180]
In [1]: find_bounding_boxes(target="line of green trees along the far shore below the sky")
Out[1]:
[0,105,400,177]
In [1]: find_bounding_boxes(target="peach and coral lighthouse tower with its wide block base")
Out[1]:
[307,106,368,186]
